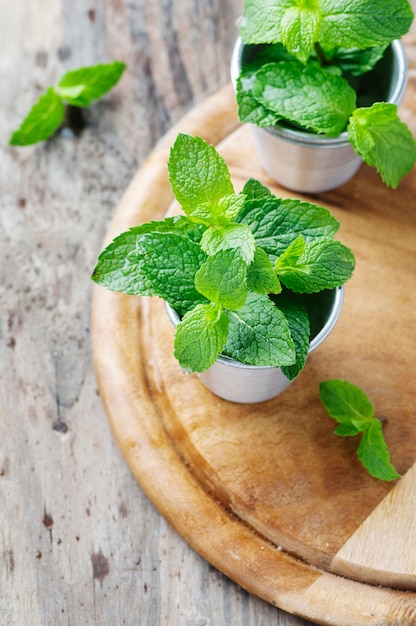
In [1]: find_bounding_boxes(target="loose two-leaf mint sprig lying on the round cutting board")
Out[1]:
[319,380,400,481]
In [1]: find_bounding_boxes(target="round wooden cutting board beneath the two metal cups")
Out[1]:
[92,86,416,626]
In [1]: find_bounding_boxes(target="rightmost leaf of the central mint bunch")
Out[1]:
[275,240,355,293]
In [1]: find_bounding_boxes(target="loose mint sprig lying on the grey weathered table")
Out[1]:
[9,61,126,146]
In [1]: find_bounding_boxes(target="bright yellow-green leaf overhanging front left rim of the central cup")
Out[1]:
[174,304,229,372]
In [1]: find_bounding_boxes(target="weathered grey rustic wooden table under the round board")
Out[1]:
[0,0,416,626]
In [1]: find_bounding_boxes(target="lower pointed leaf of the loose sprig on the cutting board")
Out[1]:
[357,419,400,480]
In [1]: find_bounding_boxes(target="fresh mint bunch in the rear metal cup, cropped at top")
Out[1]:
[237,0,416,188]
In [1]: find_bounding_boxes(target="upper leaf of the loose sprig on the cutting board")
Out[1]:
[319,379,374,430]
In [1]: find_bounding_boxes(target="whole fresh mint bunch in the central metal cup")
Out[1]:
[92,135,355,379]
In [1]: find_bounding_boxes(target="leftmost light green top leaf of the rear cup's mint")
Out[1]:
[240,0,290,43]
